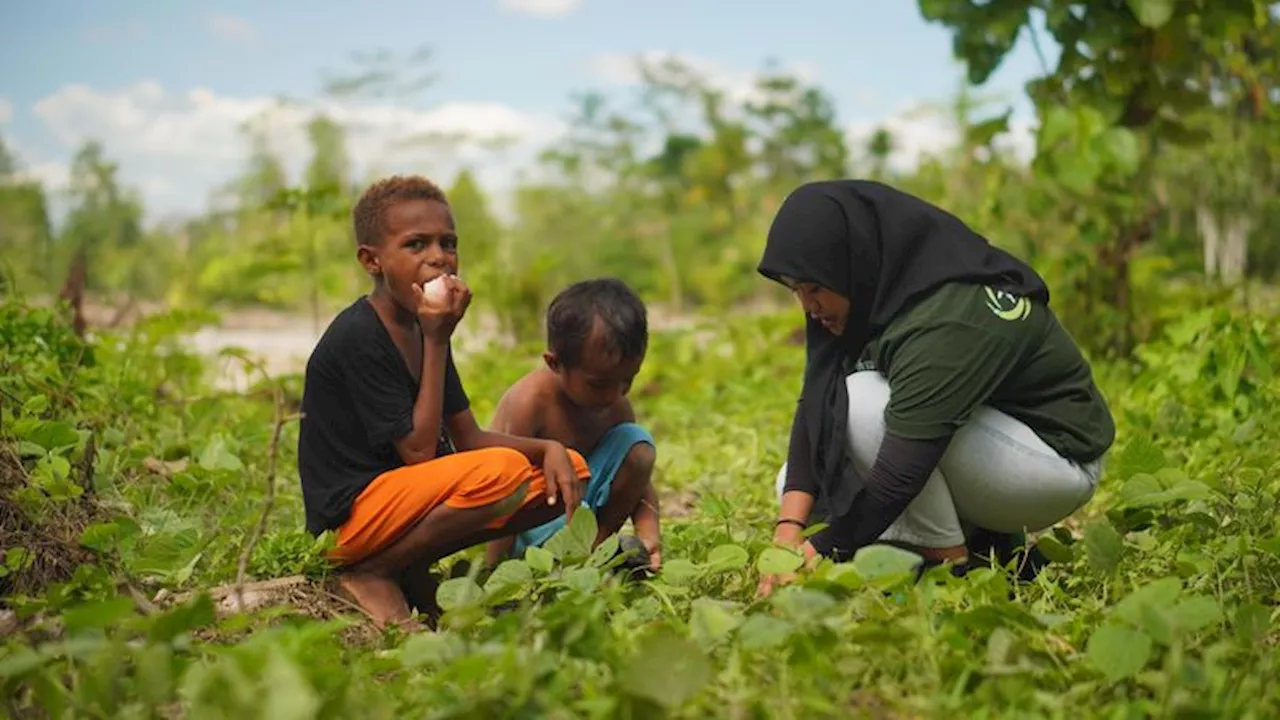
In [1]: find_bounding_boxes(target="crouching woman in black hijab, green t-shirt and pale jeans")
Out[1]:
[758,181,1115,593]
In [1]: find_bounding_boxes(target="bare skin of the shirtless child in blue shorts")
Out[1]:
[486,320,662,570]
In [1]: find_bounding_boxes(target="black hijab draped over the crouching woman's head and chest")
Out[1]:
[756,179,1048,518]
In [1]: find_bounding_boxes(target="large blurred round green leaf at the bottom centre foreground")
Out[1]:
[616,625,712,710]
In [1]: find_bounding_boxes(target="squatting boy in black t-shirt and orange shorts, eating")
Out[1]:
[298,177,590,625]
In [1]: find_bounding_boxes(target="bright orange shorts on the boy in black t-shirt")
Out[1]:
[330,447,591,564]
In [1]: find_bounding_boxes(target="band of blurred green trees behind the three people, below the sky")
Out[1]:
[0,0,1280,354]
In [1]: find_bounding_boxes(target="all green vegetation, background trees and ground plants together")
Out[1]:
[0,0,1280,719]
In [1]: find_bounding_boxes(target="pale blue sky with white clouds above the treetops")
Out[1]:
[0,0,1052,222]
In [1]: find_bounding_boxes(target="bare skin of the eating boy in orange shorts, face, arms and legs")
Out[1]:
[340,194,582,624]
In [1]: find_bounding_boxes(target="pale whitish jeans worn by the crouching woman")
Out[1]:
[777,370,1105,547]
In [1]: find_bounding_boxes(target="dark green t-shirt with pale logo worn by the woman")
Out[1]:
[858,283,1115,462]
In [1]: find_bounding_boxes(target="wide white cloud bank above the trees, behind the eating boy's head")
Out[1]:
[31,81,562,217]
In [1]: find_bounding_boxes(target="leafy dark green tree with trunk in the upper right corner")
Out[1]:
[919,0,1274,354]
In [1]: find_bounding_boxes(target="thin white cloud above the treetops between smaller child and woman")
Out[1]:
[591,50,818,102]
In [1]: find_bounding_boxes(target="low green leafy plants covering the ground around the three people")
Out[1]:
[0,294,1280,719]
